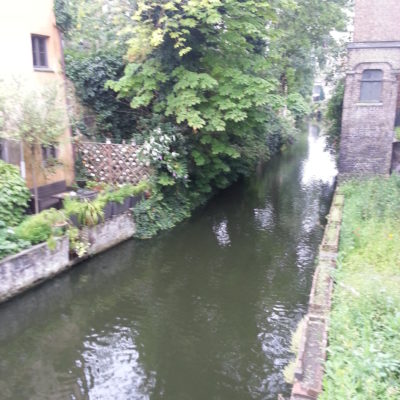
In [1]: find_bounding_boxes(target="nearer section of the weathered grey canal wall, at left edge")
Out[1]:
[0,237,69,302]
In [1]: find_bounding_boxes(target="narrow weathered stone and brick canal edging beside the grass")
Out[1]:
[290,190,344,400]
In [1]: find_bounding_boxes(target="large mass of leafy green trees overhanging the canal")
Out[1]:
[66,0,346,236]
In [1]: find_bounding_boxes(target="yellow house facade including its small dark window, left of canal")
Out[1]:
[0,0,73,188]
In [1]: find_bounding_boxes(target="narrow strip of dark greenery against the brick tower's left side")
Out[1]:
[325,79,344,147]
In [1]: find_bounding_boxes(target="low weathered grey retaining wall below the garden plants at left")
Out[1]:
[0,212,136,303]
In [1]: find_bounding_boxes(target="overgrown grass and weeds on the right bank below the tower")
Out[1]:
[320,176,400,400]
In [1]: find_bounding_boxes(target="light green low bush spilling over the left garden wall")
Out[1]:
[15,208,66,244]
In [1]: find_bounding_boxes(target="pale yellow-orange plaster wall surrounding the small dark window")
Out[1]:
[0,0,73,187]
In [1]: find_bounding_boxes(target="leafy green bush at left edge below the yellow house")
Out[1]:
[0,160,31,226]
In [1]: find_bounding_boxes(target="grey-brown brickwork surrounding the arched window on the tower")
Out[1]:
[339,57,400,179]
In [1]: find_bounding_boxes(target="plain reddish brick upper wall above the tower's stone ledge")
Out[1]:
[354,0,400,42]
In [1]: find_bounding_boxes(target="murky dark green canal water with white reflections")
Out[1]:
[0,127,336,400]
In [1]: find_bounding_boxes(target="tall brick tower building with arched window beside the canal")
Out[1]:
[339,0,400,179]
